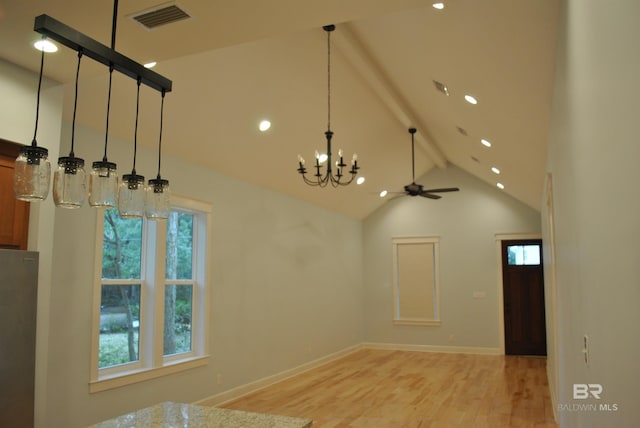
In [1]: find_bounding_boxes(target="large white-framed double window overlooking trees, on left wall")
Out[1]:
[90,196,211,392]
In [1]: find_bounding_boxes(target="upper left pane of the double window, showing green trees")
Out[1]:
[102,208,142,279]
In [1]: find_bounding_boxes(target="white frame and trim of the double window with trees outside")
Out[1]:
[89,195,212,393]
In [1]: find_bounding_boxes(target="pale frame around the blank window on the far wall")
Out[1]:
[391,236,441,326]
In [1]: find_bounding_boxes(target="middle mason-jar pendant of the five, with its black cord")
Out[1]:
[89,65,118,208]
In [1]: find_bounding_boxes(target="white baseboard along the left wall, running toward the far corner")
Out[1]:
[193,344,362,406]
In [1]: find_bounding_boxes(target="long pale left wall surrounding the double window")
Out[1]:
[0,62,363,427]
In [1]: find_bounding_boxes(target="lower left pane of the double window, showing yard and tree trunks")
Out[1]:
[98,284,140,368]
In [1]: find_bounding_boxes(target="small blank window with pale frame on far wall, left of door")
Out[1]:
[392,237,440,325]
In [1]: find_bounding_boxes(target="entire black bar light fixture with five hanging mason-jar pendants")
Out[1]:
[13,0,172,220]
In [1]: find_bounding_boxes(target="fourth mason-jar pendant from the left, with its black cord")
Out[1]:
[118,77,145,218]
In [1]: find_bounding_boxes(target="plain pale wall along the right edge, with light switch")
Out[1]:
[542,0,640,427]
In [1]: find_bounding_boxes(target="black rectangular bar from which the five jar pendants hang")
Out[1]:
[33,15,171,92]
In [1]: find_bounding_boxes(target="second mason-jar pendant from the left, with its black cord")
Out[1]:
[53,49,87,209]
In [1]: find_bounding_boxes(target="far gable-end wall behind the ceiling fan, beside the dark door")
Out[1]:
[364,165,540,352]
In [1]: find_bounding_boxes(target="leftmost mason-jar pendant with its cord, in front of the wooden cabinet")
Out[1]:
[13,39,51,202]
